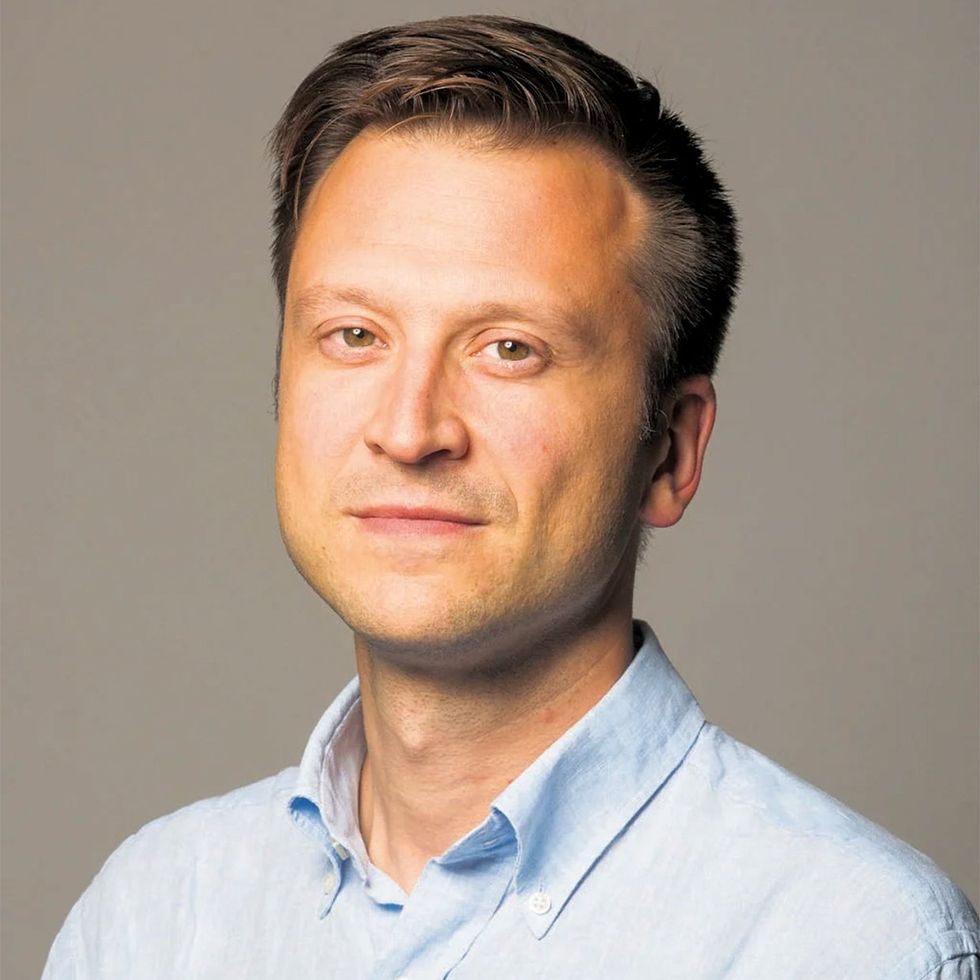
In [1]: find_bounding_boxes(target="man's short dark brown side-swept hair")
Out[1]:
[269,14,740,437]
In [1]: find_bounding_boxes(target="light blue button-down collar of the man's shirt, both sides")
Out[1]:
[288,620,705,938]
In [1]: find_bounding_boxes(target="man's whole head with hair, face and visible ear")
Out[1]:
[272,16,738,672]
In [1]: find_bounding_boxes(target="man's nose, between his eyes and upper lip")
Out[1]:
[364,352,469,463]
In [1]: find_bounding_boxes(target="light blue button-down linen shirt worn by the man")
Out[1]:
[44,622,980,980]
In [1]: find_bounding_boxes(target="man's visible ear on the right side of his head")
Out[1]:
[639,374,716,527]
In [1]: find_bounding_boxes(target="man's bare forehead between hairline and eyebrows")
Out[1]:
[288,131,647,322]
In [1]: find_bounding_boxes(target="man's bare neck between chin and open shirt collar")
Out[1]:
[355,607,634,894]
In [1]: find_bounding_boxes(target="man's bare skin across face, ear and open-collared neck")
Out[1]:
[276,131,715,894]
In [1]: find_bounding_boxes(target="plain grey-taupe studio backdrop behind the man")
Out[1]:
[3,0,980,980]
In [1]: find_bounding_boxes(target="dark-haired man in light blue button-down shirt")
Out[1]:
[45,16,980,980]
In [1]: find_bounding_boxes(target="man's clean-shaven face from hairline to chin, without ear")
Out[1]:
[276,126,650,666]
